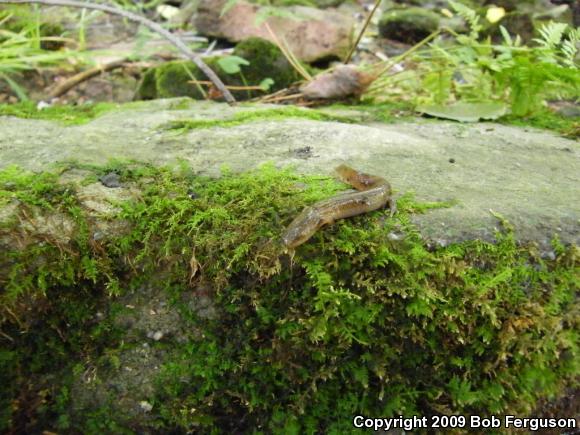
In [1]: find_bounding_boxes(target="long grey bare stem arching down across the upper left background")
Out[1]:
[0,0,236,104]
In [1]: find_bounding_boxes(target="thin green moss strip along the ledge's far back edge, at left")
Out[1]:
[0,101,120,125]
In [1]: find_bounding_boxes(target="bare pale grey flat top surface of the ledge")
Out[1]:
[0,99,580,246]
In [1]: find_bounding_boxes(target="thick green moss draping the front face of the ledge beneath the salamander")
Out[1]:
[0,165,580,433]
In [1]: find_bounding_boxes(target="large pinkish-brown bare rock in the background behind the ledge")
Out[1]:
[195,0,353,62]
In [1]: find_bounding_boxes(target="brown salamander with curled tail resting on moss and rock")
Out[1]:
[282,165,396,249]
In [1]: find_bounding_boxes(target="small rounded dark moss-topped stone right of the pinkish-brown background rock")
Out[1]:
[379,7,439,44]
